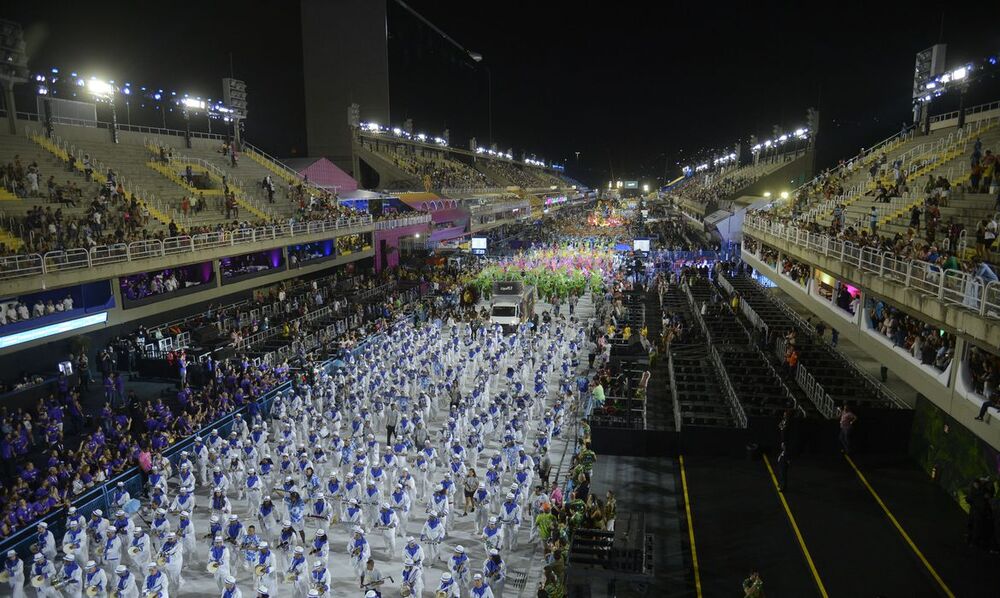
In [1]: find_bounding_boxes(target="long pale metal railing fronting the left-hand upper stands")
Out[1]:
[0,215,372,280]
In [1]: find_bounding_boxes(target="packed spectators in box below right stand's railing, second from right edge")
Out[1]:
[868,300,955,371]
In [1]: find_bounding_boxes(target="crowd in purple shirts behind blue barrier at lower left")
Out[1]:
[0,354,285,538]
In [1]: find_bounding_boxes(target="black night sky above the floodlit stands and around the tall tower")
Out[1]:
[4,0,1000,184]
